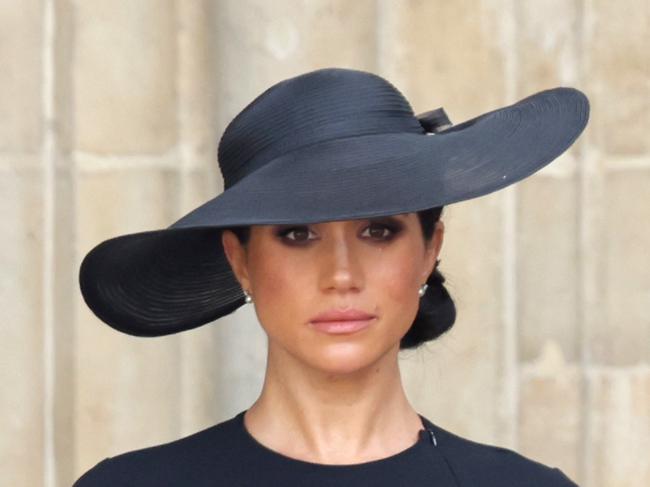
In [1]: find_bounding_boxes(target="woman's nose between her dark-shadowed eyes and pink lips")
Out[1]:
[321,232,363,292]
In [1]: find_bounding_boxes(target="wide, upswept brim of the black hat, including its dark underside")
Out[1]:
[79,87,589,336]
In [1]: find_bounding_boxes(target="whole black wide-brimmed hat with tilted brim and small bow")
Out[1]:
[79,68,589,336]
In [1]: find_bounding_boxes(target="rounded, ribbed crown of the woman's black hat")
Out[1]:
[218,68,423,189]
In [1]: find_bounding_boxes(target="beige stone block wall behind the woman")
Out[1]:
[0,0,650,487]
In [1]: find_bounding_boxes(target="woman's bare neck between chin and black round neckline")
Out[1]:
[245,344,422,464]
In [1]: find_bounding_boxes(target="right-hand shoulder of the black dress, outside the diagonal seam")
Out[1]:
[429,422,577,487]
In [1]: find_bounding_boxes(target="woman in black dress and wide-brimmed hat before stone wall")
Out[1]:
[75,68,589,487]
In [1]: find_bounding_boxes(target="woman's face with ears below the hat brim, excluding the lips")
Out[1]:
[222,213,443,373]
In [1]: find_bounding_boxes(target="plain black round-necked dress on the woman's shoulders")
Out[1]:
[73,411,577,487]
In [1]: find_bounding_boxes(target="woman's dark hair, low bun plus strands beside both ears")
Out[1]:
[227,210,456,350]
